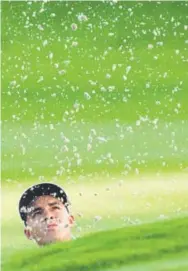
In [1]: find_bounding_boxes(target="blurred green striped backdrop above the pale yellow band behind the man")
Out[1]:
[2,1,188,181]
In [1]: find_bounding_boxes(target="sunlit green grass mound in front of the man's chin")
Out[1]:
[3,218,188,271]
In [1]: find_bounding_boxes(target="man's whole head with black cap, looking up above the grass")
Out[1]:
[19,183,74,245]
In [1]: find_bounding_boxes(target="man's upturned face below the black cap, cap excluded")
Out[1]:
[25,196,74,245]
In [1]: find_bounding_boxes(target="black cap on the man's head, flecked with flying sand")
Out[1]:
[19,183,70,222]
